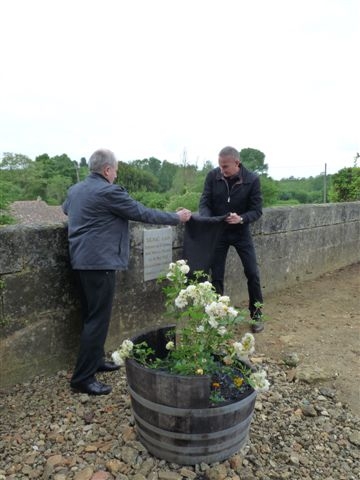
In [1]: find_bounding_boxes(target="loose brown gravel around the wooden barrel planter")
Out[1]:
[0,356,360,480]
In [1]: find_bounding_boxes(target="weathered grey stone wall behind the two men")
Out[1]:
[0,202,360,387]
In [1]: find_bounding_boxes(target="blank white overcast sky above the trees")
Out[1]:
[0,0,360,179]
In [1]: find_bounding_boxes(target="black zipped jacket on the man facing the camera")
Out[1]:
[199,165,262,228]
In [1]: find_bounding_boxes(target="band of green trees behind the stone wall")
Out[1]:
[0,148,360,224]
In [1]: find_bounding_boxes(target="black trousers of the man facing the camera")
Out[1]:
[211,229,263,315]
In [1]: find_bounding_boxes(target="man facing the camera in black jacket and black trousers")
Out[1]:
[199,147,264,333]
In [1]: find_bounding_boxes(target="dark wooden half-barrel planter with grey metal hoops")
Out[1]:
[126,326,256,465]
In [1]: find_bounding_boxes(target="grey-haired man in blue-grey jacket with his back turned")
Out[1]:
[63,149,191,395]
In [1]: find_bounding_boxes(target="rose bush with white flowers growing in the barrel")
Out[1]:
[112,260,269,403]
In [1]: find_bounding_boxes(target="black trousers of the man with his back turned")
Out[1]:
[71,270,115,383]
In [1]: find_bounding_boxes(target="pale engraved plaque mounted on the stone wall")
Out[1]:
[144,227,172,282]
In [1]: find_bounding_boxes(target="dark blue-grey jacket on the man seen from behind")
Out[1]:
[62,173,179,270]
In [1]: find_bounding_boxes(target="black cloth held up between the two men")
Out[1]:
[183,213,229,275]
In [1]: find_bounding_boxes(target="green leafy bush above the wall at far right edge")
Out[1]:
[329,166,360,202]
